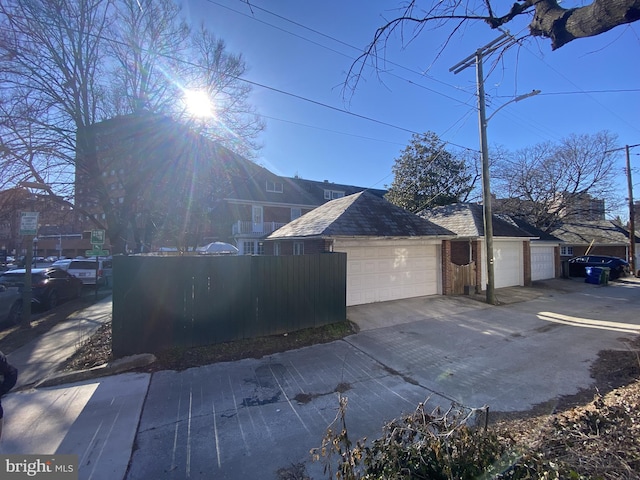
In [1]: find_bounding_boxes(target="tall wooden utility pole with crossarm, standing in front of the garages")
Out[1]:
[449,33,514,305]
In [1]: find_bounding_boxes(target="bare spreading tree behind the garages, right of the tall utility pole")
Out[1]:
[491,131,617,230]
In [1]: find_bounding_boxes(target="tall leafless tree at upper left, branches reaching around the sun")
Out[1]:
[0,0,263,250]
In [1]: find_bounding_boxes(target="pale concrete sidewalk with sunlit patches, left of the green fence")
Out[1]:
[0,296,151,480]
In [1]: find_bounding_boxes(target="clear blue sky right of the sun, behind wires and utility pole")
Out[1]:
[183,0,640,212]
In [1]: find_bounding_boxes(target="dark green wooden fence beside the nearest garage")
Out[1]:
[112,253,347,357]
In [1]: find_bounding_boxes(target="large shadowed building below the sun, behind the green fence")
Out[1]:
[76,113,385,255]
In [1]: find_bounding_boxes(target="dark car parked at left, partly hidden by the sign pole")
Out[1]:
[0,267,82,310]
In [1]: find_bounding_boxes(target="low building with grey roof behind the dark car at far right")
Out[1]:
[550,220,640,265]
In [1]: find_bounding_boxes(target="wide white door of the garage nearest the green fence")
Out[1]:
[334,240,440,306]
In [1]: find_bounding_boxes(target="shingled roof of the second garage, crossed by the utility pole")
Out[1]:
[418,203,535,238]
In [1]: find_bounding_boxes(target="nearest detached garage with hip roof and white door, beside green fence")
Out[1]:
[267,191,454,306]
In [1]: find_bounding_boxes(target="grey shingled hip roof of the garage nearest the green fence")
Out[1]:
[267,191,453,240]
